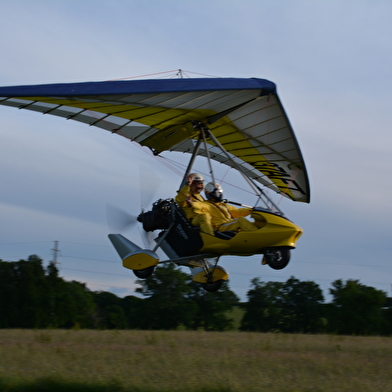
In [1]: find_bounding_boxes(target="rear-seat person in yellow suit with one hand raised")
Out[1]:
[175,173,214,235]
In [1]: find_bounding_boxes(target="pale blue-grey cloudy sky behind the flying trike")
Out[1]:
[0,0,392,301]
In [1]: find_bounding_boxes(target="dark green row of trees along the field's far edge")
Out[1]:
[0,256,392,335]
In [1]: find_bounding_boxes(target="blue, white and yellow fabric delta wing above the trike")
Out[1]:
[0,78,310,202]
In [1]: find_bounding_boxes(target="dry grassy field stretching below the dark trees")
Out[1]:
[0,330,392,392]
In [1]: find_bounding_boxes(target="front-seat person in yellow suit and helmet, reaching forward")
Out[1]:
[192,182,258,232]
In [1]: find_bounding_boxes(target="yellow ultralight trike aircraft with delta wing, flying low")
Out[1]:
[0,78,310,291]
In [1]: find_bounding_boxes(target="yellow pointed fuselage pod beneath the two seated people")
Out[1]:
[200,211,303,256]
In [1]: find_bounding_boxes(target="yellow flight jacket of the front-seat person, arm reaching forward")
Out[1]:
[193,200,252,230]
